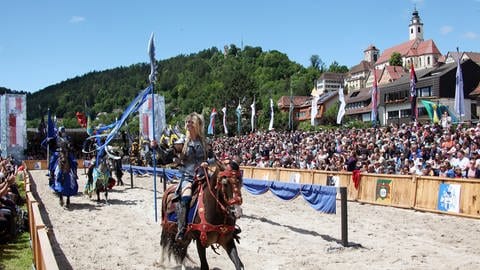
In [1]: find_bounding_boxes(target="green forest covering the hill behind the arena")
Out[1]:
[9,44,348,135]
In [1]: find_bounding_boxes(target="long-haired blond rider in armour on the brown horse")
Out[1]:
[174,113,215,241]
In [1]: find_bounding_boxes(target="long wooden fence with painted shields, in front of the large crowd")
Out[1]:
[242,167,480,218]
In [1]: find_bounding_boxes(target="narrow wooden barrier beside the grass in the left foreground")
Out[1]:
[23,165,59,270]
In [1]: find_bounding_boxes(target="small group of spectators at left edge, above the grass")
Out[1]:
[0,157,28,244]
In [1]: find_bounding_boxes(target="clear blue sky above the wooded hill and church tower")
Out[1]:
[0,0,480,92]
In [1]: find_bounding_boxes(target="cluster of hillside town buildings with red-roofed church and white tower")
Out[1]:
[278,9,480,125]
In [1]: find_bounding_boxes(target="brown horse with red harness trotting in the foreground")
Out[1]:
[160,161,244,270]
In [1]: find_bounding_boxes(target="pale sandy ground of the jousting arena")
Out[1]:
[31,171,480,270]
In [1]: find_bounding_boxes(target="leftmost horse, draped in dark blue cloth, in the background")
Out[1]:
[50,147,78,208]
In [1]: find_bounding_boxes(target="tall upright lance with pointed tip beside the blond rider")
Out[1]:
[148,33,157,222]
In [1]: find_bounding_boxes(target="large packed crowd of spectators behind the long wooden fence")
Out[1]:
[212,123,480,178]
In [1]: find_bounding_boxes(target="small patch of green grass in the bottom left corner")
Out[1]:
[0,232,33,270]
